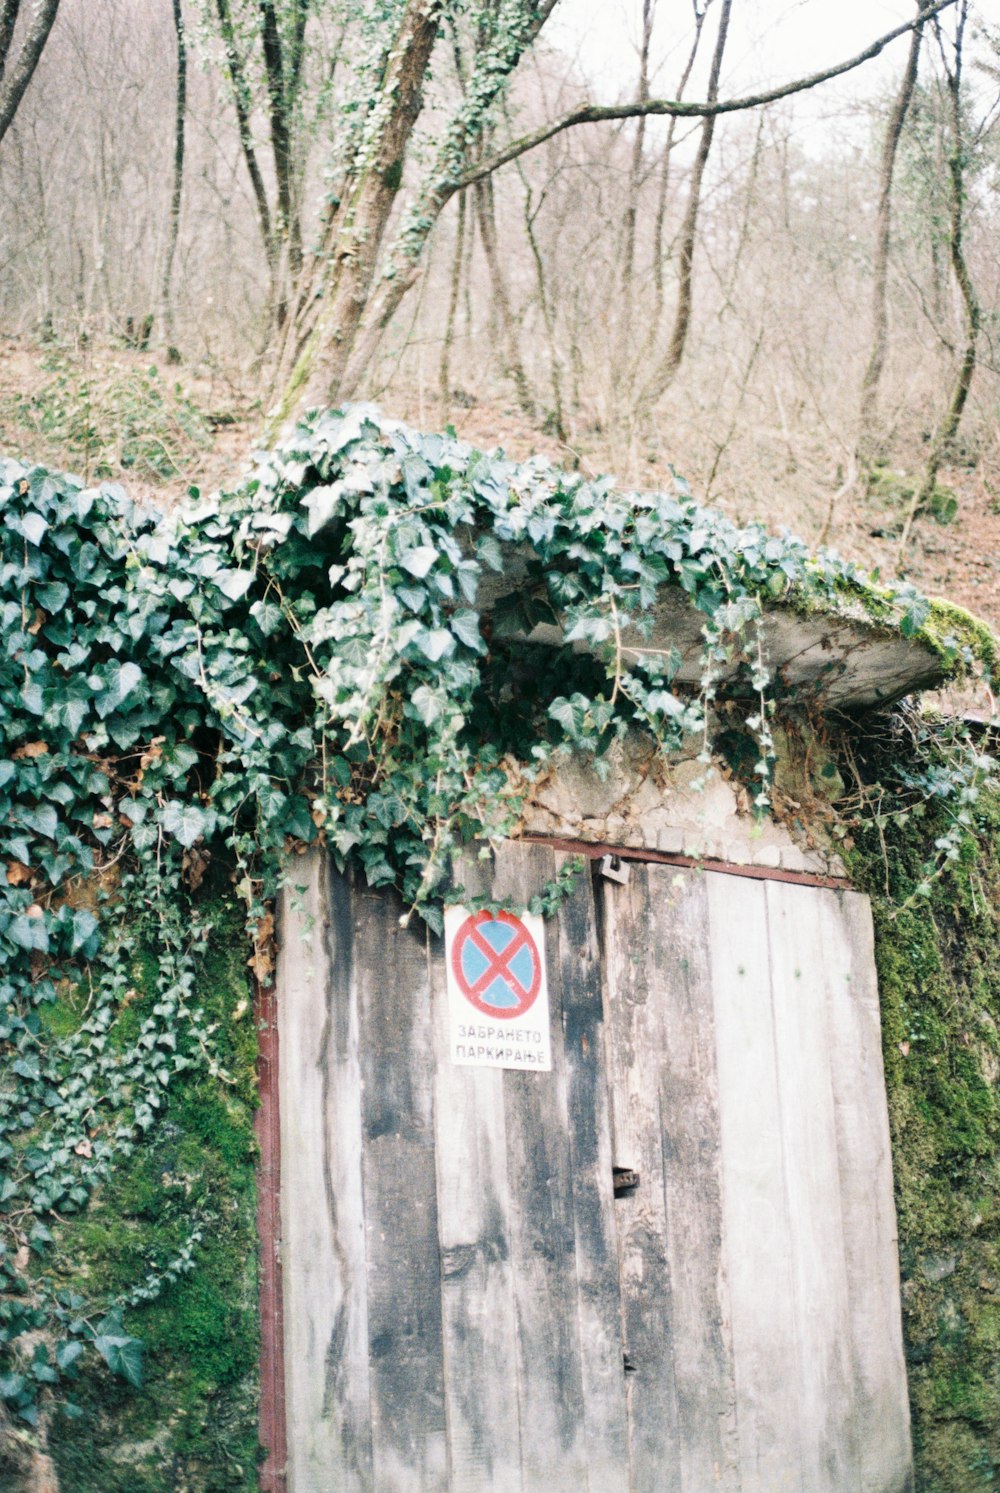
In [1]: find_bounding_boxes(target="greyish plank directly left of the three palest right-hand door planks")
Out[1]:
[650,866,740,1493]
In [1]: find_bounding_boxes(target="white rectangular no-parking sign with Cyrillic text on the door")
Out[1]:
[445,908,552,1072]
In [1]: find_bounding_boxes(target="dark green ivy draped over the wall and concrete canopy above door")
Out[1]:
[0,406,991,1424]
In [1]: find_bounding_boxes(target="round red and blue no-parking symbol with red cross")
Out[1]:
[451,911,542,1021]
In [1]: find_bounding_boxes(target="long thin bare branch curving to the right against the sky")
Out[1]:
[454,0,955,188]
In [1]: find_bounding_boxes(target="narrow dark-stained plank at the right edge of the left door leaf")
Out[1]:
[555,855,630,1493]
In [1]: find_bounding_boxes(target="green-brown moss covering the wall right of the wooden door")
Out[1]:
[854,796,1000,1493]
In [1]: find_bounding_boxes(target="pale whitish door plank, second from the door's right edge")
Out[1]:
[766,882,860,1493]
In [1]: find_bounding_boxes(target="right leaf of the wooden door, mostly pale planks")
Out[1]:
[599,864,910,1493]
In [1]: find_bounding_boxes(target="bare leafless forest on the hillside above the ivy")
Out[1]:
[0,0,1000,626]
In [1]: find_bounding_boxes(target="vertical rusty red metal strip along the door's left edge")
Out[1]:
[254,979,288,1493]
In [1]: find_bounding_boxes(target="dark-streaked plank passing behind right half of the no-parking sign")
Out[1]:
[494,844,588,1493]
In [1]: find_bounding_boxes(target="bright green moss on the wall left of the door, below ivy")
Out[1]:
[51,881,258,1493]
